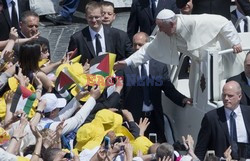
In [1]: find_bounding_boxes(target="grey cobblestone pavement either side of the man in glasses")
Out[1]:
[39,12,129,62]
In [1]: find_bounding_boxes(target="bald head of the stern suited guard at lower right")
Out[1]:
[222,81,241,110]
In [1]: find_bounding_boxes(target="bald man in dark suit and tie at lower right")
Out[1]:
[195,81,250,160]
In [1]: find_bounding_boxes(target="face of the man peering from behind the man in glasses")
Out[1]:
[102,6,115,25]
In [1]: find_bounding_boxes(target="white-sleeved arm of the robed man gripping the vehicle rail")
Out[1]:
[220,21,242,53]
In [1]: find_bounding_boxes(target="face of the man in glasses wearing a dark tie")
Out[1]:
[86,8,102,32]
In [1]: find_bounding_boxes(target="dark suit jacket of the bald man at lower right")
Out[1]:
[195,105,250,160]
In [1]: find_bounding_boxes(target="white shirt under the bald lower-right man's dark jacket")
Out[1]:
[225,106,248,143]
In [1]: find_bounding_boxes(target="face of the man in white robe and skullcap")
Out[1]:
[156,19,176,36]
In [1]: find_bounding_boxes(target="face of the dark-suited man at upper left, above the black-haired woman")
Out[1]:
[20,16,39,38]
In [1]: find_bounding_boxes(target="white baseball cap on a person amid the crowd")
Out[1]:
[41,93,67,113]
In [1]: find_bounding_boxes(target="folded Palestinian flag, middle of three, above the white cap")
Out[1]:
[55,68,75,101]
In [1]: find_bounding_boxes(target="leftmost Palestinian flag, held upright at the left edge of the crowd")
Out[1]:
[10,86,36,115]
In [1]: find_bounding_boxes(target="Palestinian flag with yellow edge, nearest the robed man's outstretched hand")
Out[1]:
[89,53,116,77]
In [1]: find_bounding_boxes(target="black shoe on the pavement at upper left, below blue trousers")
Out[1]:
[45,14,72,25]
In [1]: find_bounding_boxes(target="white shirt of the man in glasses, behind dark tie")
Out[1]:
[89,26,106,53]
